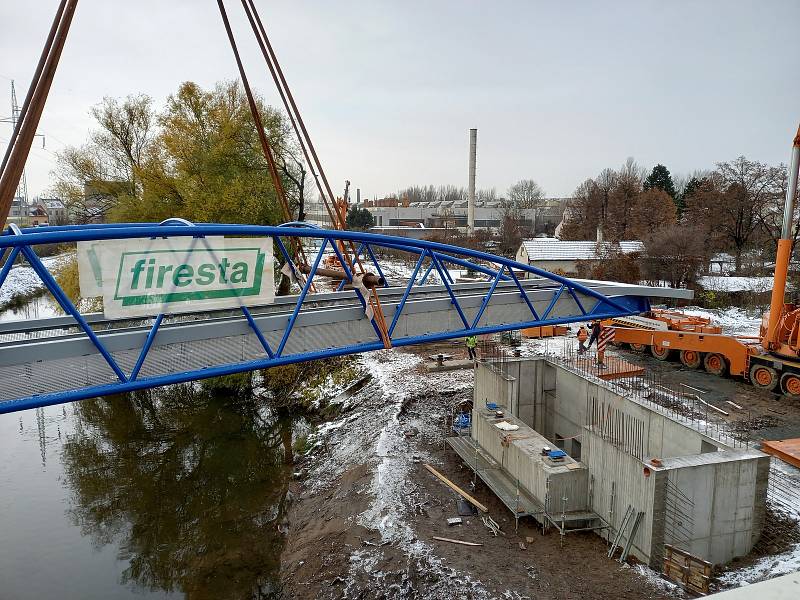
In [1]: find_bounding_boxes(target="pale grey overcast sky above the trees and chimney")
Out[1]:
[0,0,800,202]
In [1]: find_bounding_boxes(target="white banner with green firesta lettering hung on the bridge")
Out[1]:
[78,237,275,319]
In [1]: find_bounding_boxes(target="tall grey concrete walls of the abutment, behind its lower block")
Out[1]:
[475,359,769,568]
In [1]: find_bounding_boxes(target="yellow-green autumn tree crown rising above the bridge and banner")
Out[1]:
[56,82,296,224]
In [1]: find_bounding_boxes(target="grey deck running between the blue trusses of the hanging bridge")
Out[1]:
[0,279,680,410]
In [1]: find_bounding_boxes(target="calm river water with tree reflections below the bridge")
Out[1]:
[0,298,292,600]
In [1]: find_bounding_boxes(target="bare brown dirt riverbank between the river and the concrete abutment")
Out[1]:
[282,343,675,600]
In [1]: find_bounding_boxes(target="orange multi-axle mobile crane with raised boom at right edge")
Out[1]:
[605,123,800,398]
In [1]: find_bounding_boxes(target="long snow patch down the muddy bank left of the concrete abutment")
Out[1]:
[307,350,491,599]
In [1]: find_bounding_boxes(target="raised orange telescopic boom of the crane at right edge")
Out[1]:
[761,127,800,350]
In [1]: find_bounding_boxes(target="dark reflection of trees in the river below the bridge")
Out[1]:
[63,386,291,598]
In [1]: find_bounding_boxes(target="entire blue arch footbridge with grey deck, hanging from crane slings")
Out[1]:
[0,220,691,413]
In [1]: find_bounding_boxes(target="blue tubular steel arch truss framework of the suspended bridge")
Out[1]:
[0,219,649,414]
